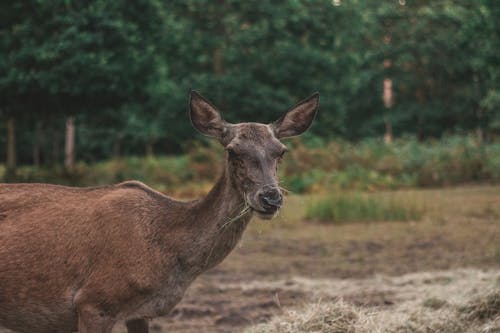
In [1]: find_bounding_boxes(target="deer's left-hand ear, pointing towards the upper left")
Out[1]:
[189,90,228,141]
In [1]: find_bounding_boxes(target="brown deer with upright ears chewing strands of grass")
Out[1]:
[0,92,319,333]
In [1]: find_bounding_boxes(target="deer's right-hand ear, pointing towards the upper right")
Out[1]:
[271,92,319,139]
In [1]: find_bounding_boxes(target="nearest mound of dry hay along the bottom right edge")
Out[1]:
[245,289,500,333]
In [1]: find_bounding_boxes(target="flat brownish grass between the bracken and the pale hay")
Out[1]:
[214,187,500,278]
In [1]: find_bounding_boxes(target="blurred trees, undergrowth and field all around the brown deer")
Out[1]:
[0,0,500,333]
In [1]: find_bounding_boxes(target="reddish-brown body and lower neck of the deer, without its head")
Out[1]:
[0,175,251,332]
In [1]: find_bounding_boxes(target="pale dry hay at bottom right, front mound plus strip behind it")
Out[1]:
[245,270,500,333]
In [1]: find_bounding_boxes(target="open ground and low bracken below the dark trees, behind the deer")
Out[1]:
[0,137,500,333]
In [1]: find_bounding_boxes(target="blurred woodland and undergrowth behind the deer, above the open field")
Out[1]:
[0,0,500,192]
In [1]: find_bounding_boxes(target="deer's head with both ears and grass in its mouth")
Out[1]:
[189,91,319,219]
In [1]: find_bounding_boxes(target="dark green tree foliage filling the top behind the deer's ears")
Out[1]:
[0,0,500,165]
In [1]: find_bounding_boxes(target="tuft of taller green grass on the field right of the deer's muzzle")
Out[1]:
[306,192,423,223]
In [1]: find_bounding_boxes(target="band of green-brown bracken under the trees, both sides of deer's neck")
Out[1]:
[0,137,500,195]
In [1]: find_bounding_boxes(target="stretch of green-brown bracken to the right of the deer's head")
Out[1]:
[282,136,500,193]
